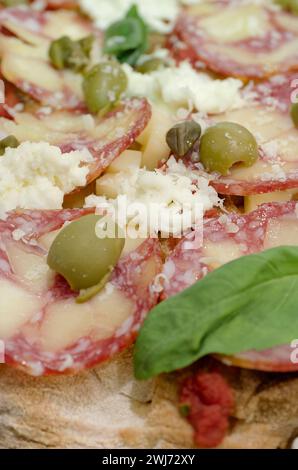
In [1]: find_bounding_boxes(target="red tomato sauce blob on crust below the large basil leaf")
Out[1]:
[179,372,235,448]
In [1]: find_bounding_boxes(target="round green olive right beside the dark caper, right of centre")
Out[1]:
[200,122,258,175]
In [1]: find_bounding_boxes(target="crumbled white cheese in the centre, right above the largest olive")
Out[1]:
[85,157,221,236]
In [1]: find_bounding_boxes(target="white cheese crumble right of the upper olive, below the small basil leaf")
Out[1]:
[123,62,244,114]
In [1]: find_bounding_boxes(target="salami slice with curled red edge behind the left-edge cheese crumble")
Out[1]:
[0,99,151,183]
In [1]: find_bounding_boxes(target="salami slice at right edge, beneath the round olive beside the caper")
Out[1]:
[191,74,298,196]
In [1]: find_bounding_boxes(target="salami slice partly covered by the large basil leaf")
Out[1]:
[162,202,298,372]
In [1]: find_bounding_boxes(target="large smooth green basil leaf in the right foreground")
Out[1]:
[134,247,298,379]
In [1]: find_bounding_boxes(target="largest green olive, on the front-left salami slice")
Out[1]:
[48,214,125,291]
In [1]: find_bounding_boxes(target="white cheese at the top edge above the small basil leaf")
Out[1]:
[79,0,199,33]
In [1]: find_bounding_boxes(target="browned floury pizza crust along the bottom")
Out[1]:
[0,351,298,449]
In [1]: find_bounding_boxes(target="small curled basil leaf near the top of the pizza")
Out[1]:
[104,6,148,65]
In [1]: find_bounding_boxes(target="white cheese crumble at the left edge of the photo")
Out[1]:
[0,142,93,218]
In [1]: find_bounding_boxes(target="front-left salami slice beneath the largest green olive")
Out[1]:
[0,210,162,375]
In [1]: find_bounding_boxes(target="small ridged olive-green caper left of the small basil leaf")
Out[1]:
[49,36,94,72]
